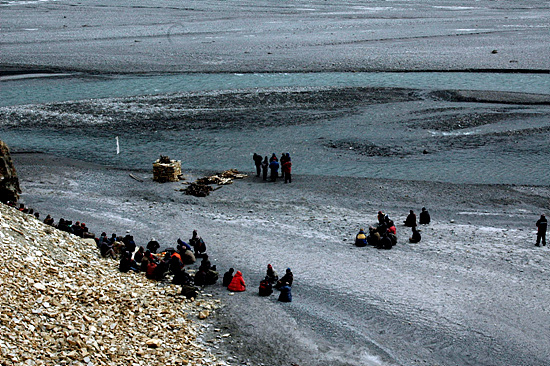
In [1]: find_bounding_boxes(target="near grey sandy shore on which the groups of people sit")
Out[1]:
[14,154,550,365]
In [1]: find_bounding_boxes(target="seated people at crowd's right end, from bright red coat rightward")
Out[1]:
[222,264,294,302]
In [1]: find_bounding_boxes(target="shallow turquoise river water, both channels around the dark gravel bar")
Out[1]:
[0,72,550,185]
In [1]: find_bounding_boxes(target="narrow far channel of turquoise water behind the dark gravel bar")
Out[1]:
[0,72,550,106]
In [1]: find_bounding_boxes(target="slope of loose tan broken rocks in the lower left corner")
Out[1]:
[0,204,227,365]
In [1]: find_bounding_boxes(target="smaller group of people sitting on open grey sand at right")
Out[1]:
[355,207,430,249]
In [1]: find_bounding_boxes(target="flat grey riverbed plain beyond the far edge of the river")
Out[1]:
[0,0,550,73]
